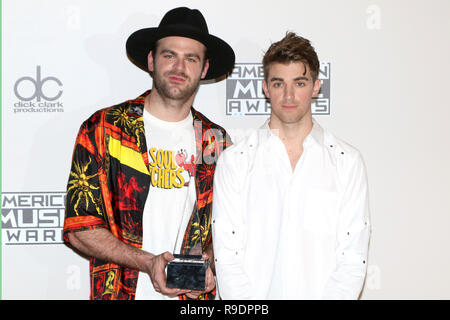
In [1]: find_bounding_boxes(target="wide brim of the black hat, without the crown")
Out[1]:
[126,25,235,80]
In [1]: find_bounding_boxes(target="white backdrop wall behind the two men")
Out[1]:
[1,0,450,299]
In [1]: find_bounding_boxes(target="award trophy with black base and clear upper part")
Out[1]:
[166,202,209,291]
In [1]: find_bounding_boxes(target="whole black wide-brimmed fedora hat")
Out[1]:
[126,7,235,80]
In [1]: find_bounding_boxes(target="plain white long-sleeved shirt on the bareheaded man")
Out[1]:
[212,121,370,299]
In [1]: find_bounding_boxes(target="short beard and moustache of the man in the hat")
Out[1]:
[153,69,200,101]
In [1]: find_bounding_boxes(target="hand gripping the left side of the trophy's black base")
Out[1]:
[147,252,191,297]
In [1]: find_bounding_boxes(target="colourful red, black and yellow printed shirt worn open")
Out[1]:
[63,91,231,299]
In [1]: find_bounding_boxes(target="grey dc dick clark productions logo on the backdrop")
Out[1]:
[14,66,64,113]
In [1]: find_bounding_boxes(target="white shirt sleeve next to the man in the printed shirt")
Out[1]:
[212,150,253,300]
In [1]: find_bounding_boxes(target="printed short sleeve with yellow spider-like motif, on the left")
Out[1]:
[63,114,107,243]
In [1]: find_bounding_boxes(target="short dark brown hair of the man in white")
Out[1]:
[262,32,319,81]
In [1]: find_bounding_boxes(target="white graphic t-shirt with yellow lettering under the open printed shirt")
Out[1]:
[136,109,196,299]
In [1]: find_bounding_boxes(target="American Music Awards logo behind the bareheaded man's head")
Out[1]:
[226,62,330,116]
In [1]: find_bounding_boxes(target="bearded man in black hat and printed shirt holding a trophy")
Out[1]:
[63,7,235,299]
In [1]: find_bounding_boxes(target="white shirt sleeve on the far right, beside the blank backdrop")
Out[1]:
[323,153,371,300]
